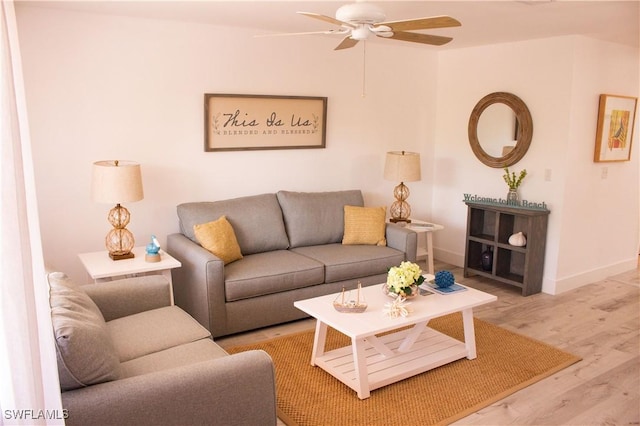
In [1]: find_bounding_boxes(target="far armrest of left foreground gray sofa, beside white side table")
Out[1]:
[81,275,171,321]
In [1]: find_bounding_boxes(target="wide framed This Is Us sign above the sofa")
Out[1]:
[204,93,327,151]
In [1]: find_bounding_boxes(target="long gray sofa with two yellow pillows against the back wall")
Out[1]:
[167,190,417,337]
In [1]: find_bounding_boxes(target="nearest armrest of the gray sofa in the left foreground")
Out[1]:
[62,351,277,426]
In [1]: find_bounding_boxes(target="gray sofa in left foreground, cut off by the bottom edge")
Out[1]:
[48,272,277,426]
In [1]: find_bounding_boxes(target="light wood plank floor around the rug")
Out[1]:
[216,262,640,426]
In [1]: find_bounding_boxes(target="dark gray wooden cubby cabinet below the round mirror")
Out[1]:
[464,201,550,296]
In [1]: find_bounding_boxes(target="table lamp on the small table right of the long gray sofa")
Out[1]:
[384,151,421,223]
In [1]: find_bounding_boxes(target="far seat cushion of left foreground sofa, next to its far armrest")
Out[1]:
[107,306,211,362]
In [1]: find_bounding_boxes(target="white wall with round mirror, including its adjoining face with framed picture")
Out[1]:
[432,37,639,294]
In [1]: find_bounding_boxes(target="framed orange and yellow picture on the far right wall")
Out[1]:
[593,95,638,163]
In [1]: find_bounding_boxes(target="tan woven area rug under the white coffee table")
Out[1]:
[228,314,580,426]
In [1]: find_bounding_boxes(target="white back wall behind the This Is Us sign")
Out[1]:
[17,3,437,280]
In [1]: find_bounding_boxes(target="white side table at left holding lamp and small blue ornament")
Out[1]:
[78,247,182,305]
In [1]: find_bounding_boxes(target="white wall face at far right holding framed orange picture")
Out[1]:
[556,37,640,292]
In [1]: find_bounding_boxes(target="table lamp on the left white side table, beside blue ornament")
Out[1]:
[91,160,144,260]
